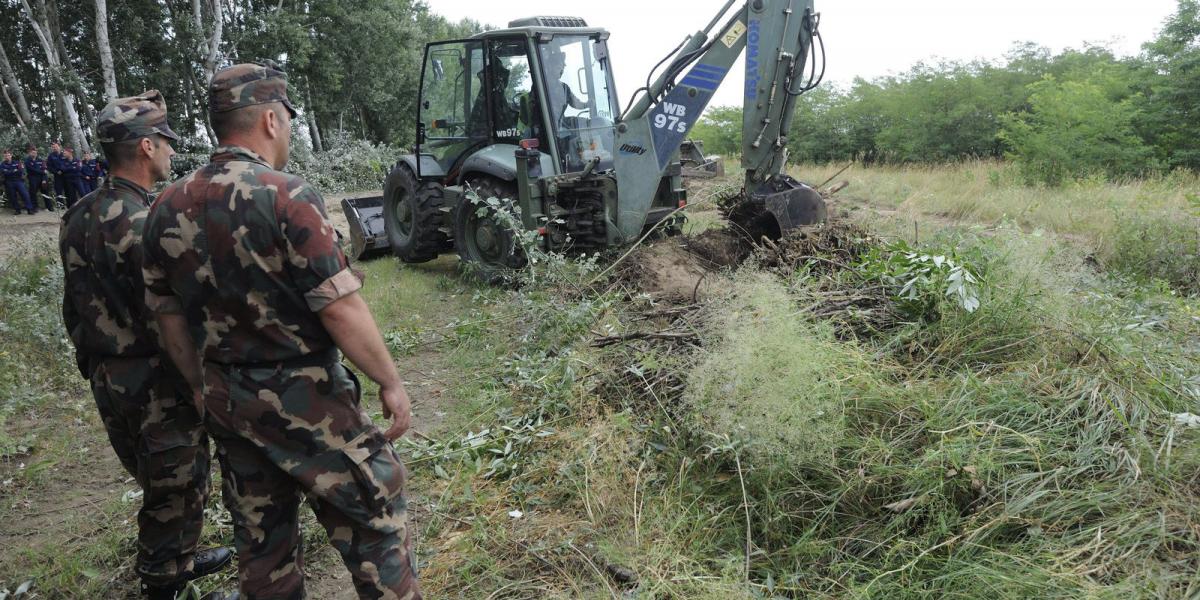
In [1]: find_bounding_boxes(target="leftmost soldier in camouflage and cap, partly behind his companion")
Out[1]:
[59,91,233,599]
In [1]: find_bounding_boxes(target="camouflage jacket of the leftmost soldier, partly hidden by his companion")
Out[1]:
[59,178,158,365]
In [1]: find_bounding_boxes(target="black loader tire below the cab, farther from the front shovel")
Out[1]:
[454,175,526,284]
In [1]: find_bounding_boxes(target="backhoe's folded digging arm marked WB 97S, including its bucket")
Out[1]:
[614,0,826,239]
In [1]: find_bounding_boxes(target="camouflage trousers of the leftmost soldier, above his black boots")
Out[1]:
[91,358,209,584]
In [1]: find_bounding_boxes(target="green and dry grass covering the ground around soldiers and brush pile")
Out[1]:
[0,163,1200,599]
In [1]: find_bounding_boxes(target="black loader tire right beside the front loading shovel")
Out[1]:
[383,167,452,263]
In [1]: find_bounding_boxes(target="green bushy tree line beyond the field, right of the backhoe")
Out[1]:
[692,0,1200,185]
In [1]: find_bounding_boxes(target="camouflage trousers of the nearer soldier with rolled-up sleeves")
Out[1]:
[204,353,421,600]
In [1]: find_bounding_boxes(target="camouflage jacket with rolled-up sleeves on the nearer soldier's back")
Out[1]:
[144,146,362,365]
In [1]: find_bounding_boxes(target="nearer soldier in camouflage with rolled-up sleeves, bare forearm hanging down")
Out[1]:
[145,64,420,600]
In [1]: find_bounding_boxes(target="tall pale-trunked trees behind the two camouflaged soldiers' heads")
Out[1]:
[0,0,480,152]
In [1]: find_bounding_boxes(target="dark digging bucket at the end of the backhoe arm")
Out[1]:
[725,175,828,241]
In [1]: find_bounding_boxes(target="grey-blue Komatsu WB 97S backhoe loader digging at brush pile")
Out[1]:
[344,0,826,280]
